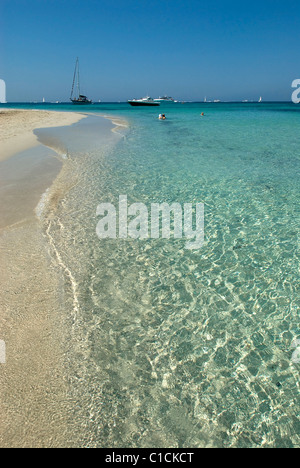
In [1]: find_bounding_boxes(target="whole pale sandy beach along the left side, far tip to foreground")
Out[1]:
[0,111,84,447]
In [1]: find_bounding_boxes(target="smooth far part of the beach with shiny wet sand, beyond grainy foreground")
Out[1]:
[0,109,86,230]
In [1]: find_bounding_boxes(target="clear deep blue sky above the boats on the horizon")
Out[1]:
[0,0,300,102]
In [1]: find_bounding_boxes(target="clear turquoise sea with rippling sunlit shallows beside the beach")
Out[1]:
[1,103,300,448]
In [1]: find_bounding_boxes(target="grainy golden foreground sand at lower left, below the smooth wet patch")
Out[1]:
[0,221,76,448]
